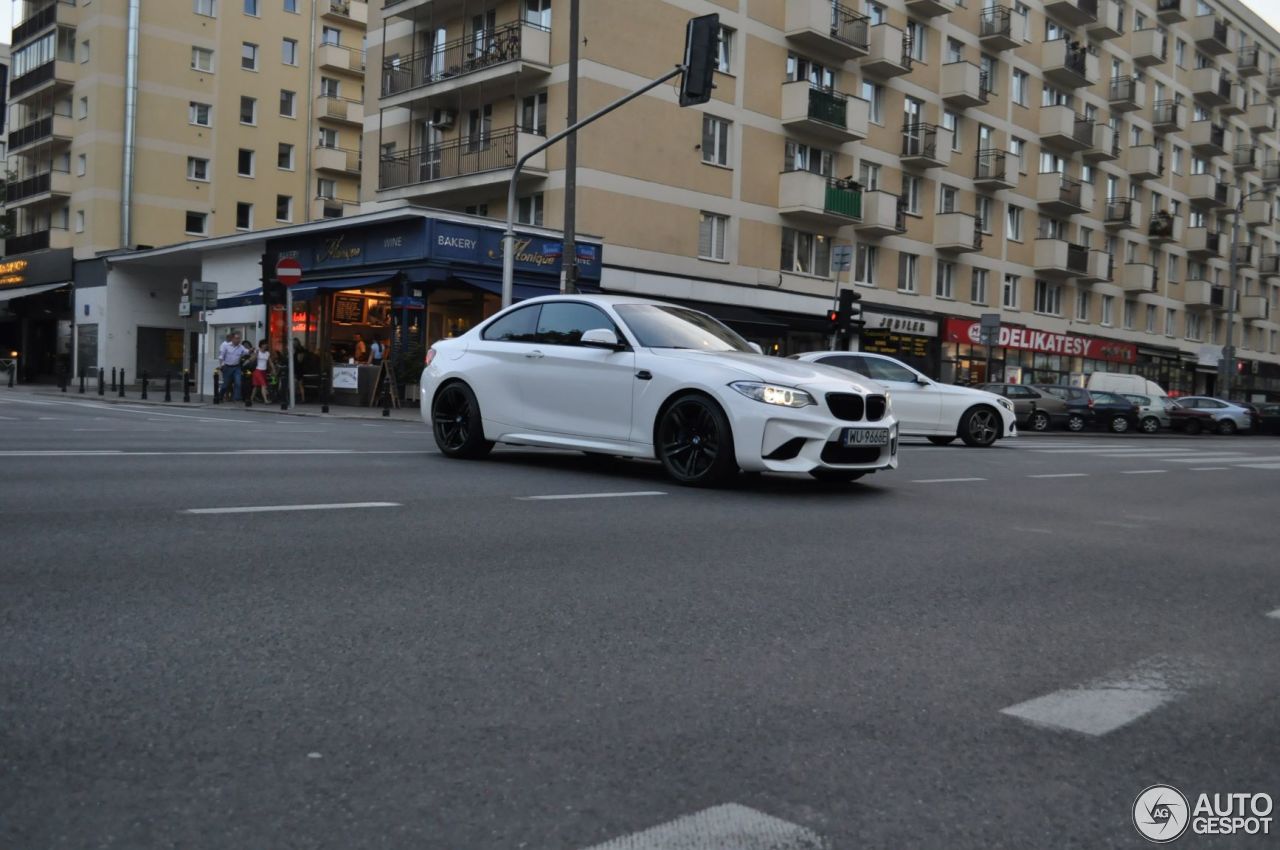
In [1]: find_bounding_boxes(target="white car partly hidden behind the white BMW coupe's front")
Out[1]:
[792,351,1018,447]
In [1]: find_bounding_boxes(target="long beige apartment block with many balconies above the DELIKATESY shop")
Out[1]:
[364,0,1280,393]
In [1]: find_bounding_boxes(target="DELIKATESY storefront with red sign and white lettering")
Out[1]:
[938,317,1138,385]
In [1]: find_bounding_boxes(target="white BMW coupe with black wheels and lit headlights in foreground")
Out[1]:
[421,296,897,485]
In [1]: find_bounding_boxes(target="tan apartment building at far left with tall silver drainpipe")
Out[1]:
[0,0,367,378]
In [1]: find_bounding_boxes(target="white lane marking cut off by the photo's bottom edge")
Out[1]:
[588,803,827,850]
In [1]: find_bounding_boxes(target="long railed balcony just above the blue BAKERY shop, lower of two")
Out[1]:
[378,127,547,201]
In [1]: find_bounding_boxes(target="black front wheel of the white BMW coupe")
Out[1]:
[658,393,737,486]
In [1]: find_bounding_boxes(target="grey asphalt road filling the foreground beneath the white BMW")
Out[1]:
[0,392,1280,850]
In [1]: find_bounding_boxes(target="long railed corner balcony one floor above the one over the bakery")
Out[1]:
[381,19,547,108]
